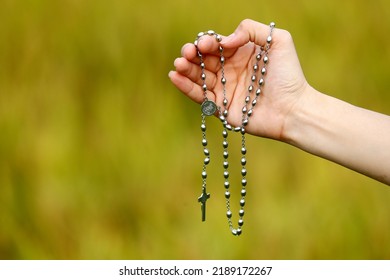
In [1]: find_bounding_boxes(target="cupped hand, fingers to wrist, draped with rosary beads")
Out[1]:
[169,20,310,140]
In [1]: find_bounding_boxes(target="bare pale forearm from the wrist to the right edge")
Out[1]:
[283,87,390,185]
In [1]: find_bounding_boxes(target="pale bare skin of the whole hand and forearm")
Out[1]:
[169,19,390,185]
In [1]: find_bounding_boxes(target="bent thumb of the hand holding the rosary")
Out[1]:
[221,19,275,48]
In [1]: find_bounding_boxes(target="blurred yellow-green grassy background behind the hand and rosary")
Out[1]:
[0,0,390,259]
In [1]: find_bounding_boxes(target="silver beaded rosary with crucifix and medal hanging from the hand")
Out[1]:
[194,22,275,236]
